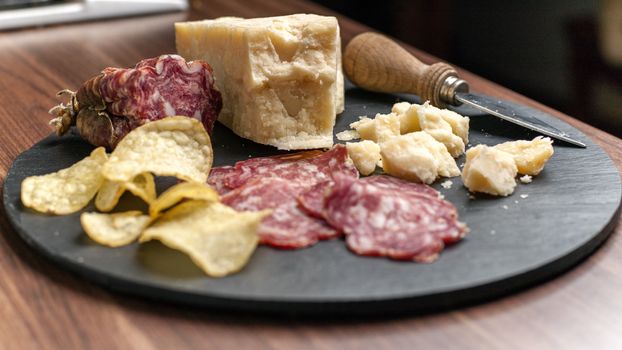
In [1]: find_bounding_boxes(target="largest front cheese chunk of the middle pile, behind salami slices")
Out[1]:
[380,131,460,184]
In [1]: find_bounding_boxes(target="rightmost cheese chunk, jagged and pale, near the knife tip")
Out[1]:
[495,136,554,176]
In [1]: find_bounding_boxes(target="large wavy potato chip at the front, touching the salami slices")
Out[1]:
[140,201,270,277]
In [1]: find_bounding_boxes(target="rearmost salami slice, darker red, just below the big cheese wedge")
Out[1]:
[225,145,358,188]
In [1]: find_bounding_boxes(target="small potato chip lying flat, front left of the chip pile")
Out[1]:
[80,210,151,247]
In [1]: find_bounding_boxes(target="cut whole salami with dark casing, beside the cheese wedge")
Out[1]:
[50,55,222,149]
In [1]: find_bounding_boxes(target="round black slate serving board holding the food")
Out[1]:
[4,86,621,314]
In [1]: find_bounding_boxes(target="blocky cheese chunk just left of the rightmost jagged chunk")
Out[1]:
[462,145,517,196]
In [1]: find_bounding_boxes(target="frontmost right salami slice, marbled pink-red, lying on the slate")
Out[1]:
[323,176,466,262]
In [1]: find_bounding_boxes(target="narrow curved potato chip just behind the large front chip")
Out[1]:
[149,182,218,218]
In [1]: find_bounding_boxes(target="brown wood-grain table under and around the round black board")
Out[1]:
[0,0,622,350]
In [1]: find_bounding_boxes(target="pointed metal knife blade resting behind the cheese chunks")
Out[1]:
[454,92,586,148]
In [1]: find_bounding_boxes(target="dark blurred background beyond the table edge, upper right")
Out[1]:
[315,0,622,136]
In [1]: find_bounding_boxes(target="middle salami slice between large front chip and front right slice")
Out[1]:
[222,177,339,249]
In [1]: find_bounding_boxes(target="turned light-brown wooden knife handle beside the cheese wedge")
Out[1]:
[343,32,466,107]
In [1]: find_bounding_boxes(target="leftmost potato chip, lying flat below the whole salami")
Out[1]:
[21,147,108,214]
